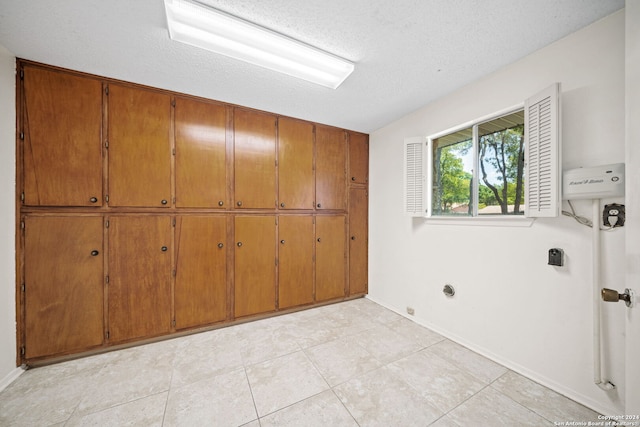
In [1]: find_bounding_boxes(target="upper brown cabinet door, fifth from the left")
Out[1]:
[278,117,313,209]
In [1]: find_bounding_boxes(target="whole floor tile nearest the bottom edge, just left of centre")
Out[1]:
[246,351,329,417]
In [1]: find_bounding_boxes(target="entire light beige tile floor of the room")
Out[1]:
[0,298,598,427]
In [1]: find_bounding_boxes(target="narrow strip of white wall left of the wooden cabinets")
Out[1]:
[0,45,16,389]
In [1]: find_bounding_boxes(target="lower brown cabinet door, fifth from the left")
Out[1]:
[278,215,313,308]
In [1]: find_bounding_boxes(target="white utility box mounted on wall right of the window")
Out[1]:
[562,163,624,200]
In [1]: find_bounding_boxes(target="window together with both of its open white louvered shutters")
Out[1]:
[404,83,561,218]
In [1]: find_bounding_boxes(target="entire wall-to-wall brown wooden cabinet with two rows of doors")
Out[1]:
[16,59,368,363]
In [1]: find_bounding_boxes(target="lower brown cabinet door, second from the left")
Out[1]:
[108,216,171,343]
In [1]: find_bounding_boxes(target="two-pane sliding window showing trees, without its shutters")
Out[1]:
[431,110,525,216]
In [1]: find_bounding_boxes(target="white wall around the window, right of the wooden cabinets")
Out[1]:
[369,11,625,414]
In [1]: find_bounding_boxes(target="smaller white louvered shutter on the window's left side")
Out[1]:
[404,137,426,216]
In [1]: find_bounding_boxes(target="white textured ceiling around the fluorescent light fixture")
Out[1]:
[0,0,624,132]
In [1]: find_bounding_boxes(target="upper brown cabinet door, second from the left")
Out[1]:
[108,84,171,207]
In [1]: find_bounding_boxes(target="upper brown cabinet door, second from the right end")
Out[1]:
[316,126,347,210]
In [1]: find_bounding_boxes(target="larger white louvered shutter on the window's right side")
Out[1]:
[524,83,561,217]
